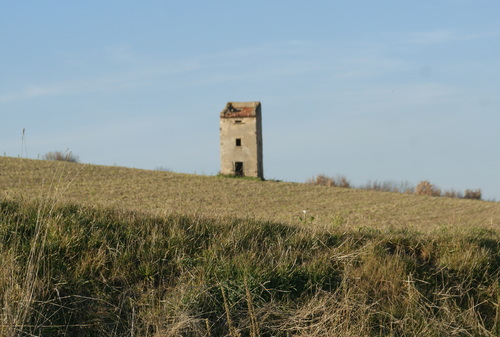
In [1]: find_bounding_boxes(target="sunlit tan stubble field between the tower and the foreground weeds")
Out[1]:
[0,157,500,230]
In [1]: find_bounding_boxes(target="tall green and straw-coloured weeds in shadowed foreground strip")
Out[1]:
[0,200,500,337]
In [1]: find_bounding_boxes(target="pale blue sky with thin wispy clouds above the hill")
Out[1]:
[0,0,500,200]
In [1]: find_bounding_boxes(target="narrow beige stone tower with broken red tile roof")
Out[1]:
[220,102,264,179]
